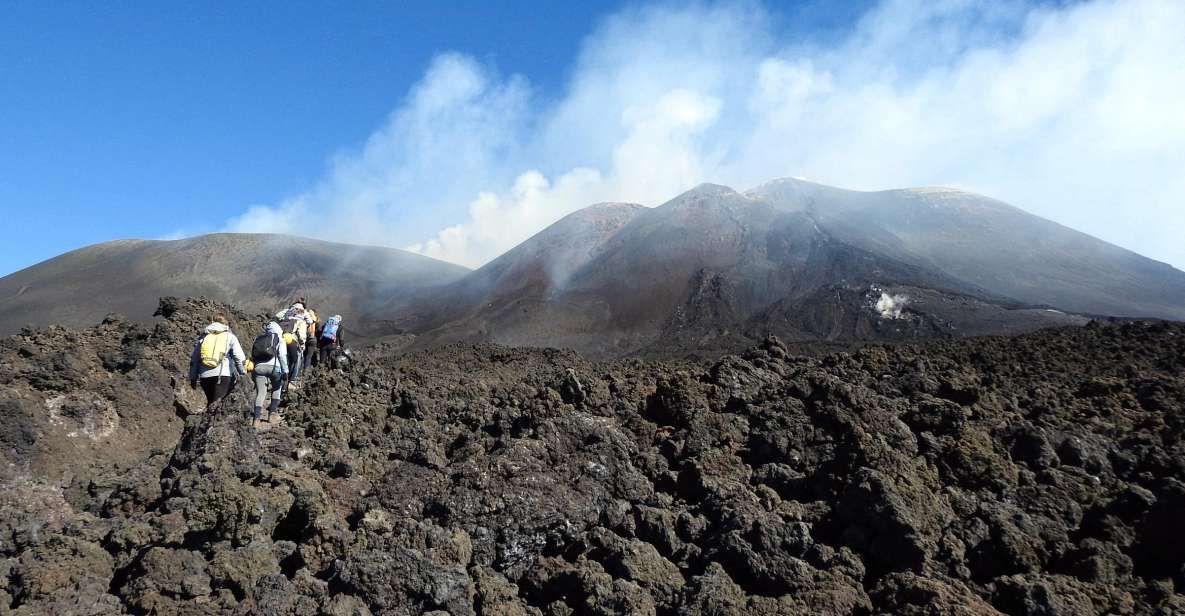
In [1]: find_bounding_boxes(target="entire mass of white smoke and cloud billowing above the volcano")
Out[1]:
[223,0,1185,267]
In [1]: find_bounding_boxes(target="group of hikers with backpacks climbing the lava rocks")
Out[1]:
[190,302,350,428]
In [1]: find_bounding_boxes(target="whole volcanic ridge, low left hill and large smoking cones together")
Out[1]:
[0,178,1185,357]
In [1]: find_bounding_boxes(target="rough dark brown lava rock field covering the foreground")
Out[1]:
[0,300,1185,616]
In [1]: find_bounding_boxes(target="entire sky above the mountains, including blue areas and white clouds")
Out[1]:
[0,0,1185,275]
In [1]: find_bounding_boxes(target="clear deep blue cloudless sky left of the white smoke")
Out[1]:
[0,1,635,274]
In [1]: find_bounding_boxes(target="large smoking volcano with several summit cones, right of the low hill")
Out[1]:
[387,179,1185,354]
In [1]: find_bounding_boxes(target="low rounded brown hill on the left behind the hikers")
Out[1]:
[0,233,468,334]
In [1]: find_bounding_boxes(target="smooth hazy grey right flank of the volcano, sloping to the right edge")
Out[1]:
[745,179,1185,320]
